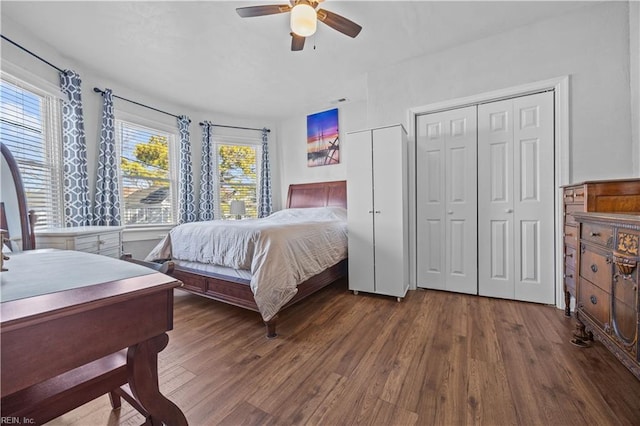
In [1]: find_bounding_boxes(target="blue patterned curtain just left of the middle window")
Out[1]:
[93,89,120,226]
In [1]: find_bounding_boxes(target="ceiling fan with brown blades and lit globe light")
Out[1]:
[236,0,362,51]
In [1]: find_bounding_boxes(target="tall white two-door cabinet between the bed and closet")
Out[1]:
[344,125,409,301]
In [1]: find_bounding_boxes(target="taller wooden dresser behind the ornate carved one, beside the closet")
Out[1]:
[562,179,640,316]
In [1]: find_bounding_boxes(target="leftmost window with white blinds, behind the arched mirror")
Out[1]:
[0,73,63,230]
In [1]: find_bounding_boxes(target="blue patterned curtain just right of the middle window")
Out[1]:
[178,115,197,223]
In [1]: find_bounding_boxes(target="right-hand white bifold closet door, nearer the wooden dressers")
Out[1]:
[478,92,555,303]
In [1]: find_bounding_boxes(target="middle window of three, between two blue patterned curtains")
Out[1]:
[116,120,177,225]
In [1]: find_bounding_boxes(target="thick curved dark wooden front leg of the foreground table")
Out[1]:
[127,333,188,426]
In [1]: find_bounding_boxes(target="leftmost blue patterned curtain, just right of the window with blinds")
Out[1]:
[60,70,91,227]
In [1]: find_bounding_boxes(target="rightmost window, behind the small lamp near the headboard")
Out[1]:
[215,142,262,218]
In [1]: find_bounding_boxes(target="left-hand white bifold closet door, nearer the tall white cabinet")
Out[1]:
[416,106,478,294]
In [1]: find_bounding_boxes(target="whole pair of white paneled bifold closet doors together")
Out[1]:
[416,92,555,303]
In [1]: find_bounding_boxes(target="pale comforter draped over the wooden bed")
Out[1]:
[146,207,347,321]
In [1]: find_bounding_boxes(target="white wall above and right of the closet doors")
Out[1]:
[368,2,635,181]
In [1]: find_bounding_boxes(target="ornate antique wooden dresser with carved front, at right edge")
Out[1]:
[573,212,640,379]
